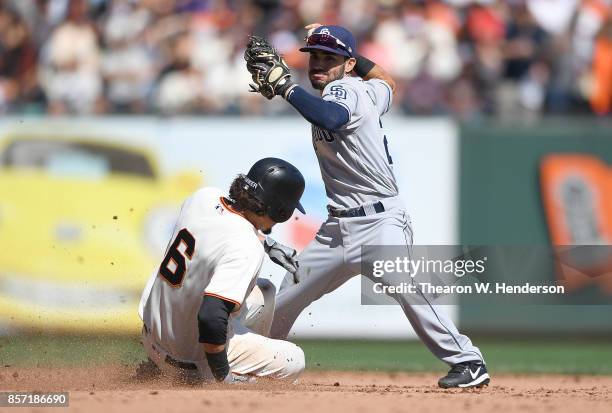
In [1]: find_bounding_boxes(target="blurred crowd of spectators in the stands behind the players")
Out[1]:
[0,0,612,120]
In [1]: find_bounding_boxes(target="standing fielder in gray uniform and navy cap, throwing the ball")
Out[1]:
[245,24,490,388]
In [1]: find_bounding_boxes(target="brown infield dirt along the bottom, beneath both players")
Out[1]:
[0,366,612,413]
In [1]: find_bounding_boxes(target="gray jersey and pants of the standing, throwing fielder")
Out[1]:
[270,77,483,364]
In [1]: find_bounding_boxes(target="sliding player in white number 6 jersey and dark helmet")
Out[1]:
[139,158,304,383]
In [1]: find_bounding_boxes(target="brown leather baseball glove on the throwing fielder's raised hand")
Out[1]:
[244,36,293,99]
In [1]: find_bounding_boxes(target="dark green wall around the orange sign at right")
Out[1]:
[459,119,612,334]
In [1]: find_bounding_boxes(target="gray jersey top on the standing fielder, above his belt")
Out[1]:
[312,76,398,208]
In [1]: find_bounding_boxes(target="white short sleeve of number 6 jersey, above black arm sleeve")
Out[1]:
[203,240,264,306]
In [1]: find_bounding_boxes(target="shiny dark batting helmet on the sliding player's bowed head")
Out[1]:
[244,158,306,222]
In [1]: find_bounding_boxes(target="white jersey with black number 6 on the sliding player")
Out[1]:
[139,188,265,361]
